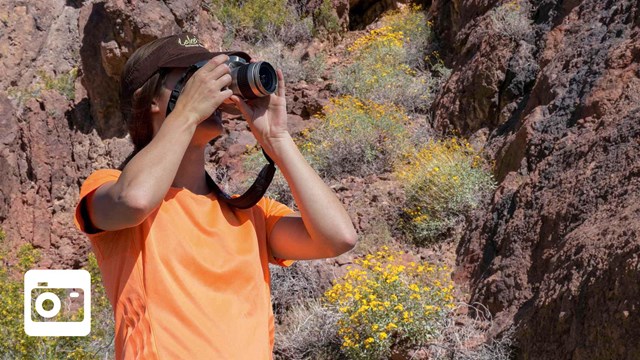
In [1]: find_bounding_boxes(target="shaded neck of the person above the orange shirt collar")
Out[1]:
[171,145,212,195]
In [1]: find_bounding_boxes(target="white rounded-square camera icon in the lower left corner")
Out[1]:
[24,270,91,336]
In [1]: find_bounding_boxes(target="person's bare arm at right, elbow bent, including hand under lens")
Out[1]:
[231,70,357,260]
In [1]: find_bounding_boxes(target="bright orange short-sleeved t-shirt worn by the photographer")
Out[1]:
[75,170,293,360]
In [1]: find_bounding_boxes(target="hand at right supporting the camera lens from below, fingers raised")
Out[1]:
[231,68,289,153]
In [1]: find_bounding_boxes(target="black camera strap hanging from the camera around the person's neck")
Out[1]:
[166,61,276,209]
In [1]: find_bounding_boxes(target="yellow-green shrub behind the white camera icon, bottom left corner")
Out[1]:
[0,238,114,359]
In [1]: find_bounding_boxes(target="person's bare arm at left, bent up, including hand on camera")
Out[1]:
[88,55,232,230]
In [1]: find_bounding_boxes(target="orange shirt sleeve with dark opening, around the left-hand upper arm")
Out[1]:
[73,169,120,235]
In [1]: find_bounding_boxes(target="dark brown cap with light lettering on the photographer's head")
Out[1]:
[121,33,251,98]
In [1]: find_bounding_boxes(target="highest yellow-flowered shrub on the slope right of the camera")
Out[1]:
[335,7,433,111]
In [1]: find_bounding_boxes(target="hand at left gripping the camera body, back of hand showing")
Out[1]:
[174,55,233,124]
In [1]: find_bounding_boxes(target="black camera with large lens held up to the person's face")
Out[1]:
[225,55,278,99]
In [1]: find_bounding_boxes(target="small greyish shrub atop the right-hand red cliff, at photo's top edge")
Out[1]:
[489,0,533,42]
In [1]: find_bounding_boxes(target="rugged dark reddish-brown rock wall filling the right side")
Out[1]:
[432,0,640,359]
